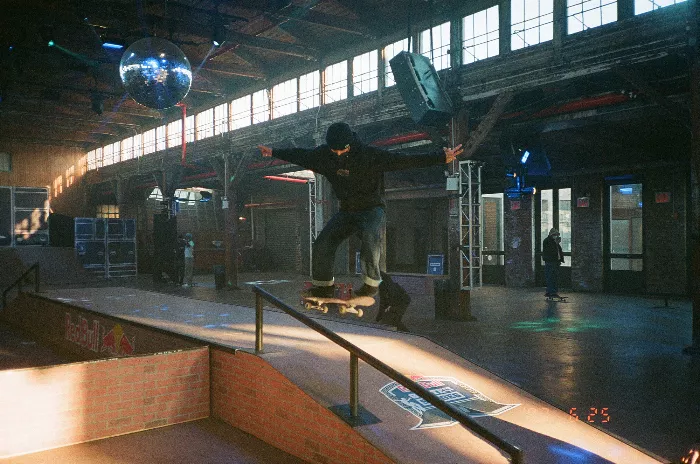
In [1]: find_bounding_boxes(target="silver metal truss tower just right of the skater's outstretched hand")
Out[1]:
[459,161,482,290]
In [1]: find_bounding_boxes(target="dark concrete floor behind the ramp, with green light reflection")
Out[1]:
[2,273,700,462]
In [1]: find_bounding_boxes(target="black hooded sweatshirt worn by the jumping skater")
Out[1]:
[272,142,445,211]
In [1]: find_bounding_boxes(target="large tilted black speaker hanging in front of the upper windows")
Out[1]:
[389,52,452,126]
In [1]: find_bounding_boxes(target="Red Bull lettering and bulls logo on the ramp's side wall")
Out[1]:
[65,313,136,356]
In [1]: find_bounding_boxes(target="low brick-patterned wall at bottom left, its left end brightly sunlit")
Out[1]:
[0,347,209,458]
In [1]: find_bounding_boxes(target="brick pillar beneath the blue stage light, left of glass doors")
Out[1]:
[503,195,535,287]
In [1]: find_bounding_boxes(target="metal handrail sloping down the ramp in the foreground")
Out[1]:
[253,285,524,464]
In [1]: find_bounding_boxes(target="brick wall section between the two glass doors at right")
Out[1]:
[571,176,604,292]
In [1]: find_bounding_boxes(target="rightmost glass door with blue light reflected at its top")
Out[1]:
[606,184,644,293]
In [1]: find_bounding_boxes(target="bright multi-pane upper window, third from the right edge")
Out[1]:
[510,0,554,50]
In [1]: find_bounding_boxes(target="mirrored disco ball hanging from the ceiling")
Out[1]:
[119,37,192,110]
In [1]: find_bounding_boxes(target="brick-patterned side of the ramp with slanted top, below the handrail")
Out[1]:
[211,347,393,464]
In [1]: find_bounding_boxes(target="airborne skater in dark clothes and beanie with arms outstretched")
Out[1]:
[258,122,463,297]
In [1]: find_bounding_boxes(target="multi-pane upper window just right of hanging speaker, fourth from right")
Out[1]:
[462,5,499,64]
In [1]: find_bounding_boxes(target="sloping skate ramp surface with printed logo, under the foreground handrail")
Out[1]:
[37,288,665,464]
